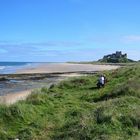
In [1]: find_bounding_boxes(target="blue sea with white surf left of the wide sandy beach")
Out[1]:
[0,62,39,74]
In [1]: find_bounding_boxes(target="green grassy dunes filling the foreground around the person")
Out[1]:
[0,65,140,140]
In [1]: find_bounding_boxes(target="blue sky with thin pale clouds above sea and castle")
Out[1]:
[0,0,140,62]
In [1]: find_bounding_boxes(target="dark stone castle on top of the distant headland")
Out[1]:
[103,51,127,59]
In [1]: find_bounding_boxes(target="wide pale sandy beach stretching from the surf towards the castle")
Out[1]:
[16,63,119,74]
